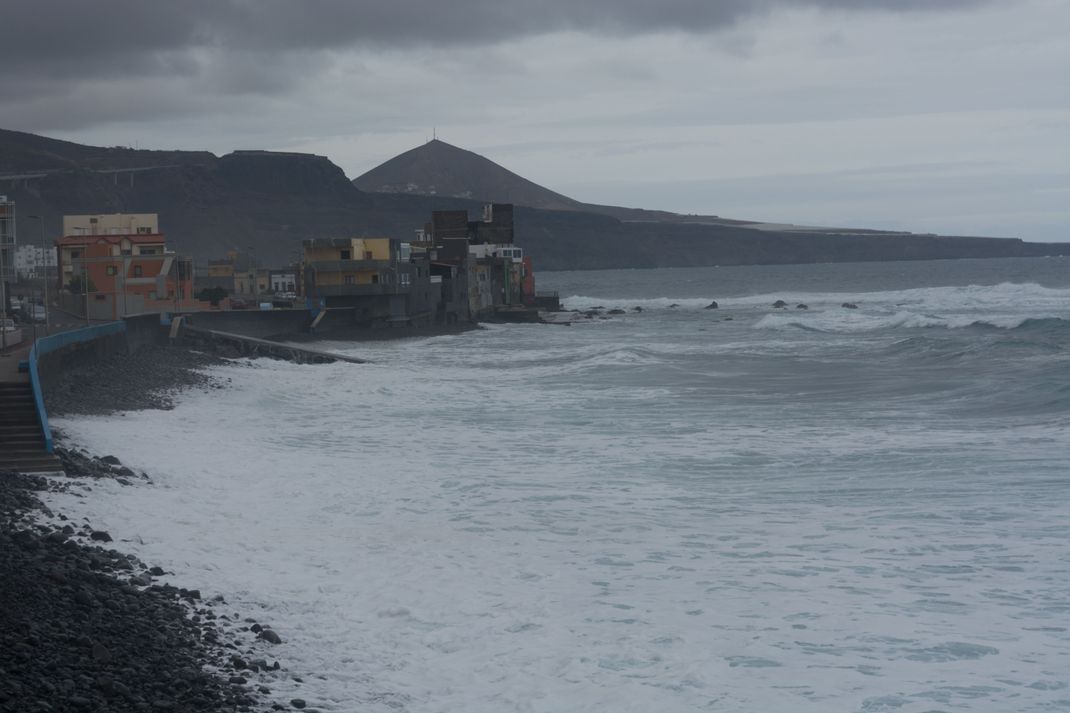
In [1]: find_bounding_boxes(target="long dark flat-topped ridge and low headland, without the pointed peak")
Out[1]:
[0,130,1070,270]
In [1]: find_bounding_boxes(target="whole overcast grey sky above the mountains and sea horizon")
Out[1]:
[0,0,1070,241]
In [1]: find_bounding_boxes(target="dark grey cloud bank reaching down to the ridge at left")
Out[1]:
[0,0,988,131]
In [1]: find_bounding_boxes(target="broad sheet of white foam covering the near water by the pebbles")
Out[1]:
[37,329,1067,713]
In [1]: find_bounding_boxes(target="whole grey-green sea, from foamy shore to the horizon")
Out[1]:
[49,258,1070,713]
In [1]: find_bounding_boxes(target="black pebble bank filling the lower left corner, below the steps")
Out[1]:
[0,472,262,713]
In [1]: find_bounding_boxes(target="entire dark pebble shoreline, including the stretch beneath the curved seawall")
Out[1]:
[0,347,325,713]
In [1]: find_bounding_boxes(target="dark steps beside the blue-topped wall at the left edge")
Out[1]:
[0,381,63,473]
